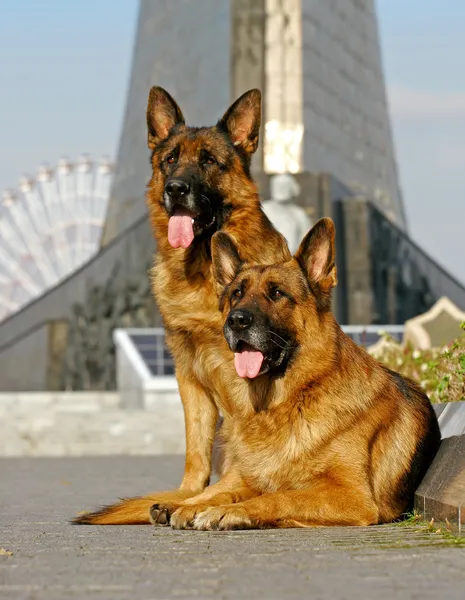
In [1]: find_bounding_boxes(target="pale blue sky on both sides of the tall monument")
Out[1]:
[0,0,465,282]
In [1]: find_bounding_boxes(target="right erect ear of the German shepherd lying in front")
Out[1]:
[294,217,337,291]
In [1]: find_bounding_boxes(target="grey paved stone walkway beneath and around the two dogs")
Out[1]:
[0,456,465,600]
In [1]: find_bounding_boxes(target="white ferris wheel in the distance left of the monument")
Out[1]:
[0,155,113,321]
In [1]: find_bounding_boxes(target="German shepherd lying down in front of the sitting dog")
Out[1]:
[144,219,440,530]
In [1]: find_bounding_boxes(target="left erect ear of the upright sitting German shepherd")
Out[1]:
[147,86,184,150]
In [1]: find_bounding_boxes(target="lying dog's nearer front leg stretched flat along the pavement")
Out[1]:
[193,479,378,530]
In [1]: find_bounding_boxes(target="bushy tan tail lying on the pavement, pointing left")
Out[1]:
[72,490,194,525]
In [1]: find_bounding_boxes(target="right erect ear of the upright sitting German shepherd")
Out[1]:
[218,89,262,154]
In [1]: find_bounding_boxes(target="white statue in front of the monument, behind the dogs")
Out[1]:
[263,173,312,254]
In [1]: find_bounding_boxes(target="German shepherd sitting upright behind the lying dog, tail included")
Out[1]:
[74,87,290,525]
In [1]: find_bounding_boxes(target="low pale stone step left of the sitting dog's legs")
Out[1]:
[0,395,185,456]
